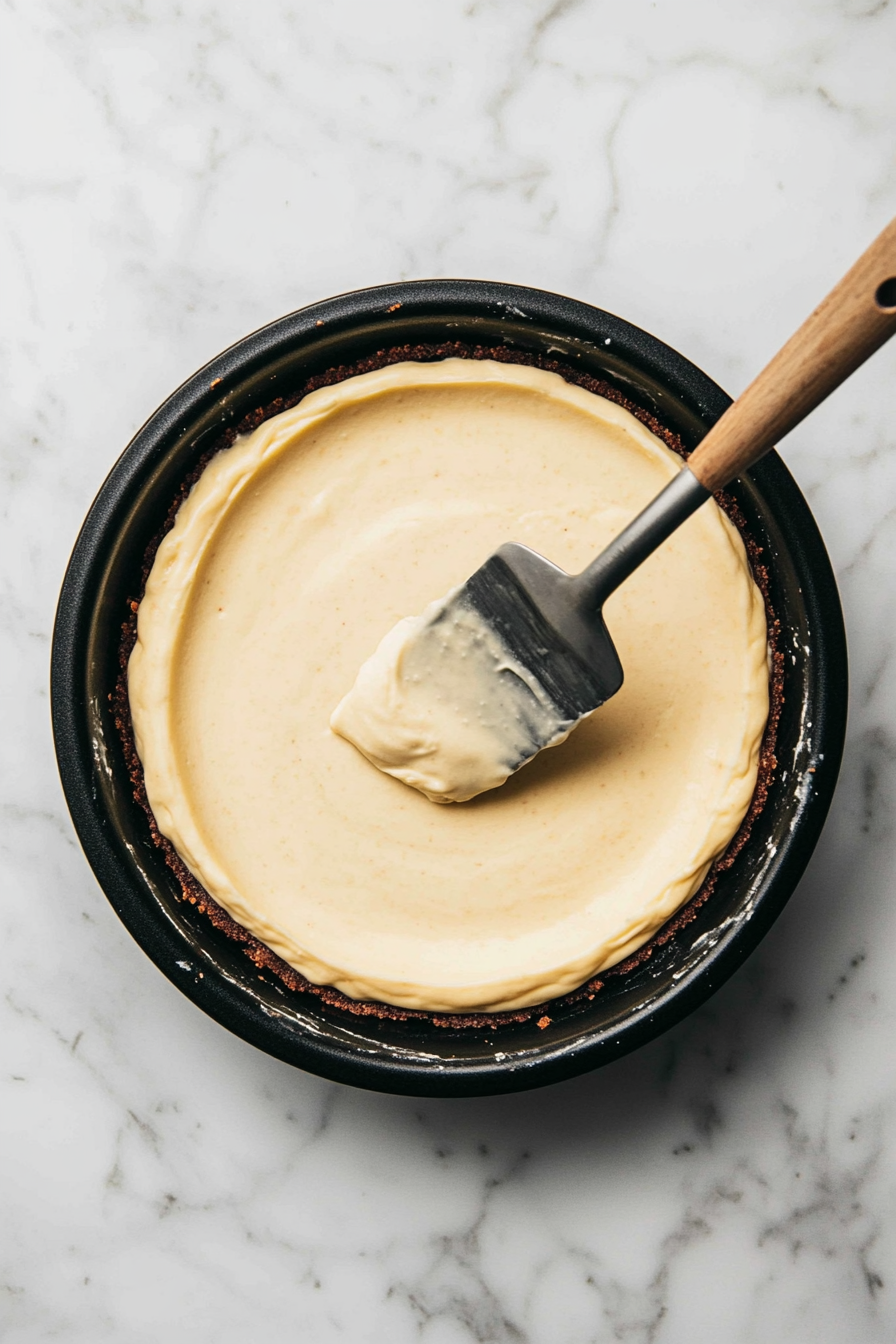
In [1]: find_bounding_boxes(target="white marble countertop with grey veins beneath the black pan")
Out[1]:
[0,0,896,1344]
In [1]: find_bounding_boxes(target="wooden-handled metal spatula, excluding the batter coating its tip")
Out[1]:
[443,219,896,769]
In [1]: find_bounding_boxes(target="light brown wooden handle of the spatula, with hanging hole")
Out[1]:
[688,219,896,491]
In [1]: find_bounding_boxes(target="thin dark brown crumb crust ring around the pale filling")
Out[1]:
[109,341,783,1031]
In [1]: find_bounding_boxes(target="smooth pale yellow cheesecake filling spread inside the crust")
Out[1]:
[129,359,768,1012]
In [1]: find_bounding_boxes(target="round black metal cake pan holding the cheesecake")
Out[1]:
[52,281,846,1097]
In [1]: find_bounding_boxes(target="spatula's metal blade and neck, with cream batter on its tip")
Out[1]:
[330,466,709,802]
